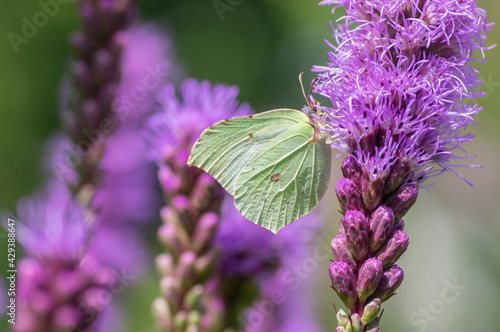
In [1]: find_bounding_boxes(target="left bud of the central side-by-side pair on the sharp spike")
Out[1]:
[340,210,368,262]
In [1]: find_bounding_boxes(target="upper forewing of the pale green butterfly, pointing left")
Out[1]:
[188,109,309,195]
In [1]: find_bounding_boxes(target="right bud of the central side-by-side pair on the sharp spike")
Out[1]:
[368,205,394,252]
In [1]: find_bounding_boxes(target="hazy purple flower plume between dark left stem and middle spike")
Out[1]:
[49,24,180,226]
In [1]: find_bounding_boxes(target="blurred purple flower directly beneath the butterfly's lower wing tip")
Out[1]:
[218,201,320,332]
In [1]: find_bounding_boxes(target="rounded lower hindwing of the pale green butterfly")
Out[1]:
[234,122,331,233]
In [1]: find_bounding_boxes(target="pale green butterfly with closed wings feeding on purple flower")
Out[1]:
[188,73,332,233]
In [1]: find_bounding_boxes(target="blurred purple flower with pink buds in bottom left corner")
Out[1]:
[14,182,141,332]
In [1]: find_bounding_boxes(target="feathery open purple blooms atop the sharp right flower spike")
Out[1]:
[315,0,491,183]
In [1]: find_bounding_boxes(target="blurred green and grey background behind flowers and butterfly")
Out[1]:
[0,0,500,332]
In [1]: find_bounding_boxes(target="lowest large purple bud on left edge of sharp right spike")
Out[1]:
[328,262,357,308]
